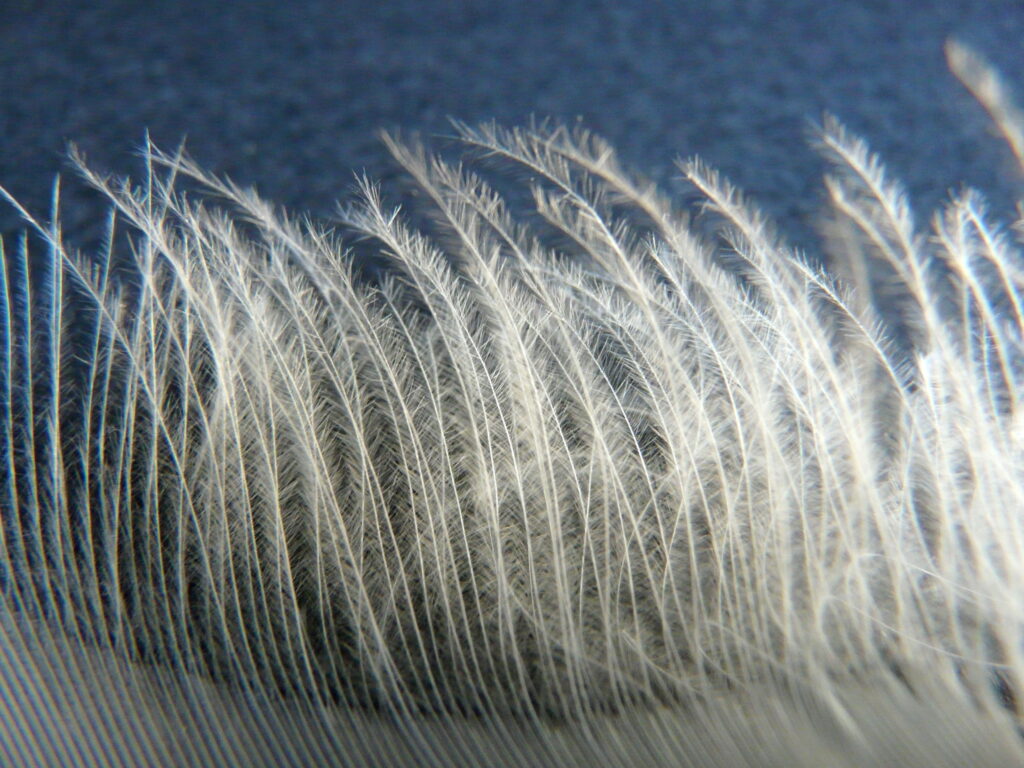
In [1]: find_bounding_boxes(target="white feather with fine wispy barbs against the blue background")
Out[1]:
[0,45,1024,766]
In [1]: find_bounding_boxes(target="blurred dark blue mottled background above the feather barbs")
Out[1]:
[0,0,1024,257]
